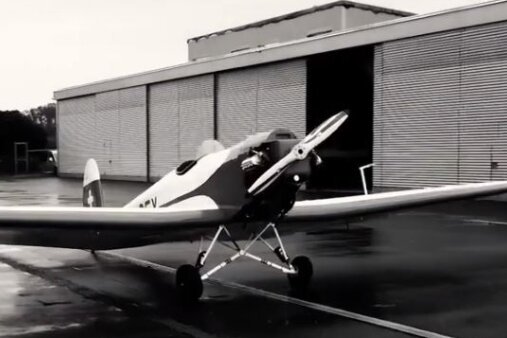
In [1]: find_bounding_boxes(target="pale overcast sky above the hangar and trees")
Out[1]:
[0,0,496,110]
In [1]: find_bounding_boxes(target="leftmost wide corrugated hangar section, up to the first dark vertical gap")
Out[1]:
[58,87,146,180]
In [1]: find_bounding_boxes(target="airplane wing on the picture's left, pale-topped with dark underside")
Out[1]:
[0,207,237,250]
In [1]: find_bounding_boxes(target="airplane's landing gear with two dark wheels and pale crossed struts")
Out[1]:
[176,223,313,300]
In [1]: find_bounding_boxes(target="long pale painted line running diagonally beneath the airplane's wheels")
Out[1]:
[96,252,451,338]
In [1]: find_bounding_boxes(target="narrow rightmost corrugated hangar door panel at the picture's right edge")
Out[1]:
[460,23,507,182]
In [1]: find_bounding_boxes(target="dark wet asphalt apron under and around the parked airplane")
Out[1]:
[0,177,507,337]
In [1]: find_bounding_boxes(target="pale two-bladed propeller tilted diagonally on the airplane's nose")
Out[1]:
[248,111,349,195]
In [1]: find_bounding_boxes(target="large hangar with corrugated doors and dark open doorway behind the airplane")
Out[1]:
[54,0,507,190]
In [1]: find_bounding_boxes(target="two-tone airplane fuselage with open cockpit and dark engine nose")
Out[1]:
[125,129,310,221]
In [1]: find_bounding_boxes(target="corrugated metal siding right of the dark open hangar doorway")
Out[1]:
[374,23,507,187]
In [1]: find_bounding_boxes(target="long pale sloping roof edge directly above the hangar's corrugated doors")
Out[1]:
[54,0,507,100]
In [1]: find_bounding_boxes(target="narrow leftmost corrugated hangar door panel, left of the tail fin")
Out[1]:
[58,95,96,175]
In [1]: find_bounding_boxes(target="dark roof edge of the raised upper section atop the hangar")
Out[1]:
[187,0,414,41]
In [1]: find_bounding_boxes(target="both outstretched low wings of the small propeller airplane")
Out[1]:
[0,181,507,250]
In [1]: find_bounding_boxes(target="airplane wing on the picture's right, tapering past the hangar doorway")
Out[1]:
[284,181,507,222]
